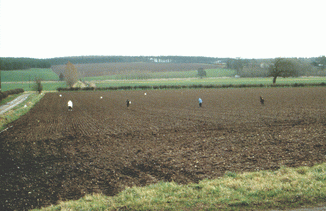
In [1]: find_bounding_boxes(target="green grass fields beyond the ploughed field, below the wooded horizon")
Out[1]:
[1,68,326,91]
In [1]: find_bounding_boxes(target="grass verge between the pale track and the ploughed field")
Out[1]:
[0,93,44,131]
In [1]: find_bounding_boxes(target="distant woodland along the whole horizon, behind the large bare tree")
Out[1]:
[0,56,326,77]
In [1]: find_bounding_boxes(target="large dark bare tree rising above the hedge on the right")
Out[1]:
[268,58,298,84]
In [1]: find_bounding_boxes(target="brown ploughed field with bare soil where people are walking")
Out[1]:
[0,87,326,210]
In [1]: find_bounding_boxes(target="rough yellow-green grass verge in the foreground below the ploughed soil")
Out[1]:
[32,163,326,211]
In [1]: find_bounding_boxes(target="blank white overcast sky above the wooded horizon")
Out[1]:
[0,0,326,58]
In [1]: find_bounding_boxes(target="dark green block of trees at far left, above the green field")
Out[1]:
[0,57,51,70]
